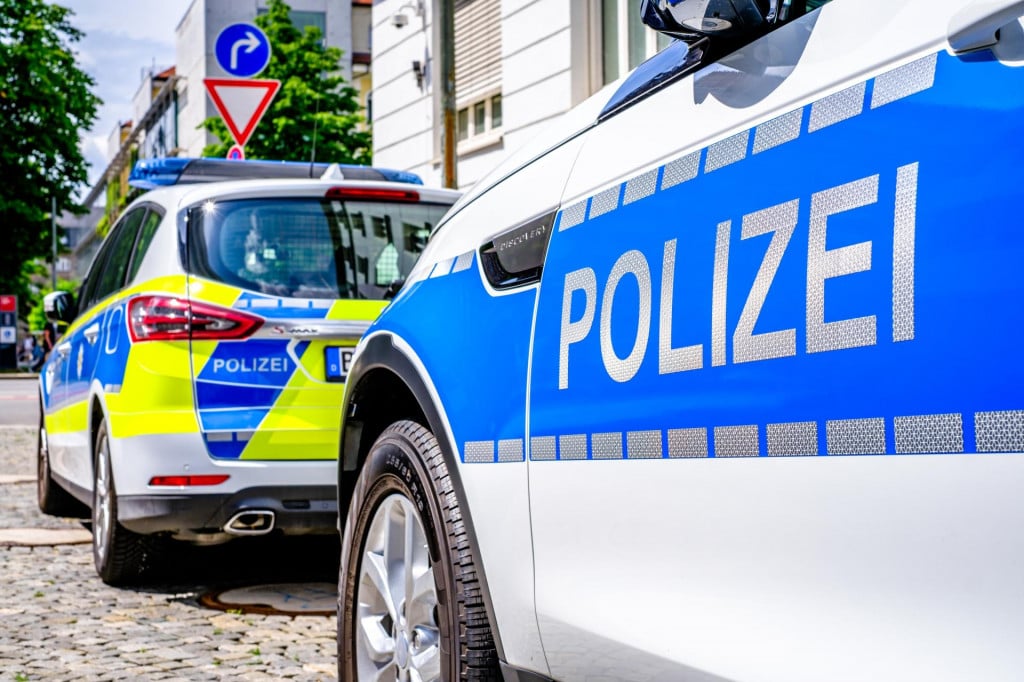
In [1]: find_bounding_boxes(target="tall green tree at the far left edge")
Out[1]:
[0,0,99,319]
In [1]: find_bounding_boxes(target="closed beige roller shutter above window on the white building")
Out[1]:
[455,0,502,106]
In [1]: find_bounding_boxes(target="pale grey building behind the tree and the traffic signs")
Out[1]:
[175,0,370,157]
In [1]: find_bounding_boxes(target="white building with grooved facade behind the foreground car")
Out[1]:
[372,0,668,188]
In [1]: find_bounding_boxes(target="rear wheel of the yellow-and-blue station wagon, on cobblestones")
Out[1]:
[92,421,162,587]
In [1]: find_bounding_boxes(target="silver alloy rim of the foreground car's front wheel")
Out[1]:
[354,495,441,682]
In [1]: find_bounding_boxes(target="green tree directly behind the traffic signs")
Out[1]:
[201,0,371,164]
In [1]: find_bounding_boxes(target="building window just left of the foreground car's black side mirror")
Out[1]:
[601,0,672,83]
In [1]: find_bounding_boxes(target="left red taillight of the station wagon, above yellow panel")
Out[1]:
[128,296,263,342]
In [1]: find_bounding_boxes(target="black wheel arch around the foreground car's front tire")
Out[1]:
[338,333,505,665]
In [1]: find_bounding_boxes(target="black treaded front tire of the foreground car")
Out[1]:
[338,421,502,682]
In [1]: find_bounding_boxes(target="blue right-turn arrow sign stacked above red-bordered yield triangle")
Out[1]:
[203,24,281,160]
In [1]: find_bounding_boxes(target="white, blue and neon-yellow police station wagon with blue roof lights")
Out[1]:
[38,159,458,584]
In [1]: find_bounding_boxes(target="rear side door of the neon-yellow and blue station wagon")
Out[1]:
[56,205,146,488]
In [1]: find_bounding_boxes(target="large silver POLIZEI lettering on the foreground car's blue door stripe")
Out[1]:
[558,163,918,389]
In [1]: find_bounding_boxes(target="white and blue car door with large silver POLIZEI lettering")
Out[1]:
[528,0,1024,680]
